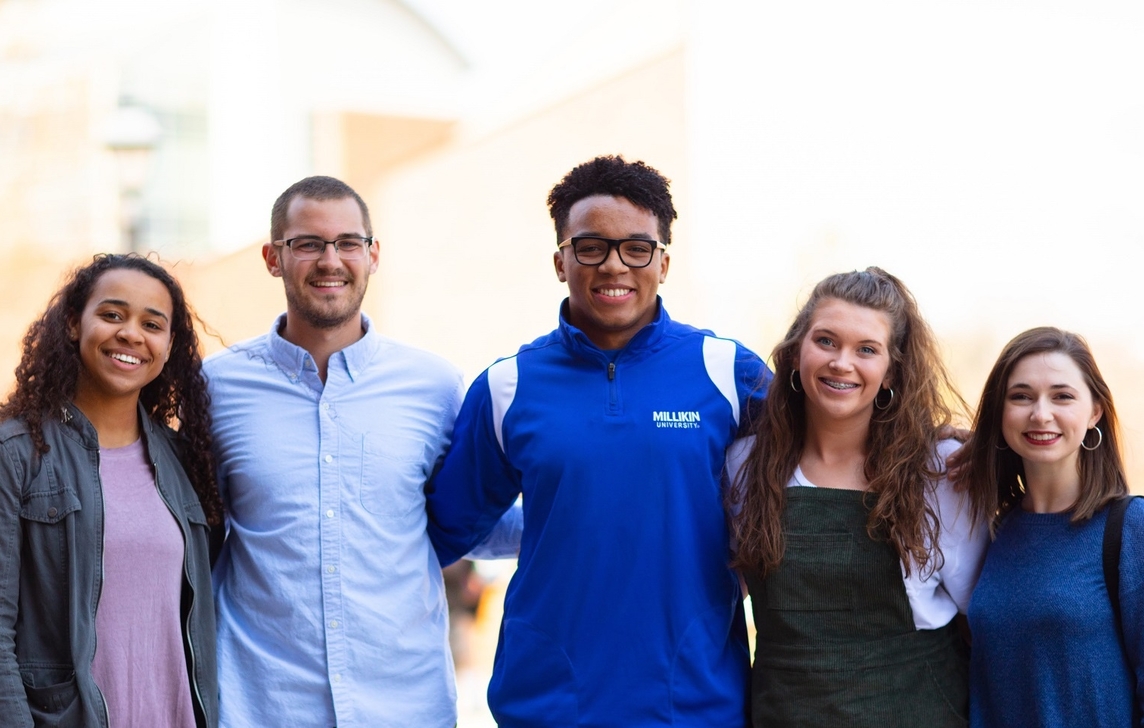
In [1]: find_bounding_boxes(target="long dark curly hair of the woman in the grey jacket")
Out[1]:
[0,253,223,525]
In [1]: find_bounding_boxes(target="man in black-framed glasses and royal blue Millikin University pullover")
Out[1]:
[428,157,770,728]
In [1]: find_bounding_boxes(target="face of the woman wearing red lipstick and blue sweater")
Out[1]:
[1001,351,1102,474]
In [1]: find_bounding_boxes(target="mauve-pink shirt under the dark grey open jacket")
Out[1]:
[92,440,194,728]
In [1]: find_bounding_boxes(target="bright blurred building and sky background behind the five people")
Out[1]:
[0,0,1144,725]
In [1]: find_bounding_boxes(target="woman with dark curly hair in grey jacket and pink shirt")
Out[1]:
[0,255,222,728]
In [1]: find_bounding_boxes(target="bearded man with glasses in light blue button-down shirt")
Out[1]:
[204,176,519,728]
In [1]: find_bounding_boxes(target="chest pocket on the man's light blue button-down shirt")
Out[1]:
[360,433,429,519]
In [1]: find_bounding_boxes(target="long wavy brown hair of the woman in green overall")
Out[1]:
[728,268,966,575]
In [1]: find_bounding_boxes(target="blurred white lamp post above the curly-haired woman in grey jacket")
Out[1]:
[104,104,161,253]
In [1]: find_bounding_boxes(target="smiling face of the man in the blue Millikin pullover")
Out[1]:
[554,195,669,350]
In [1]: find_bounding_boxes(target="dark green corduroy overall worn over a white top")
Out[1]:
[747,488,969,728]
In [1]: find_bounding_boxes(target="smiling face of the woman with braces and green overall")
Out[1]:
[795,299,891,425]
